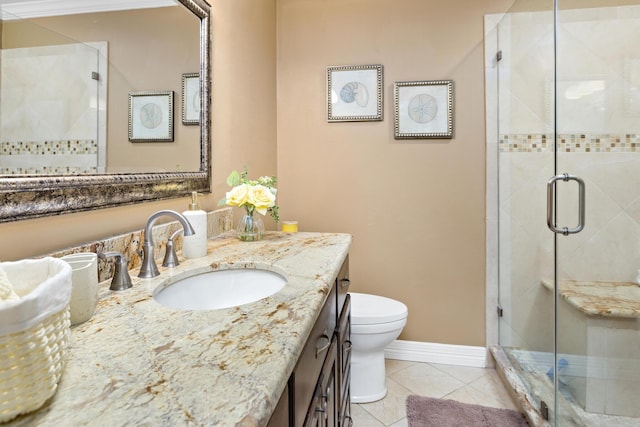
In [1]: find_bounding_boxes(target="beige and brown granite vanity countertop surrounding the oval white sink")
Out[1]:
[6,232,351,427]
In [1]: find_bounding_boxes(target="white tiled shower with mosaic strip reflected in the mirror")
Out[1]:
[0,43,106,175]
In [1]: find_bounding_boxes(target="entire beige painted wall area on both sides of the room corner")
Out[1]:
[0,0,511,346]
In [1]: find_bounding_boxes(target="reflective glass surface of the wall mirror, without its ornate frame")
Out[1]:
[0,1,200,175]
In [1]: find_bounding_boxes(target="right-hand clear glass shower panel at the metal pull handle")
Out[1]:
[556,0,640,426]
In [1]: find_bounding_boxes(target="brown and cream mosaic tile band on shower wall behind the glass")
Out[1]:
[498,134,640,153]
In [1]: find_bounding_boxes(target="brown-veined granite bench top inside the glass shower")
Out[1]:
[542,280,640,318]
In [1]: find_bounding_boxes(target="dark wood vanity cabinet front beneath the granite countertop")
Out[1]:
[268,257,352,427]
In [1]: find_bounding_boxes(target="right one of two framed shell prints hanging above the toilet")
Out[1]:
[393,80,453,139]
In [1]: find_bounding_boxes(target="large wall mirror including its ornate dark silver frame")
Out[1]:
[0,0,211,226]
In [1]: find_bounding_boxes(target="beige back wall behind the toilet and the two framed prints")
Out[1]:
[278,0,512,346]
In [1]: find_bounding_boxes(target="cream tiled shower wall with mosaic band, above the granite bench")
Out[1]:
[498,6,640,351]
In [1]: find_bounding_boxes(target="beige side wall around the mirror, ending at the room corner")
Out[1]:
[0,0,276,260]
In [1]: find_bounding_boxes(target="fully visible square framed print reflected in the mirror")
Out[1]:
[129,91,173,142]
